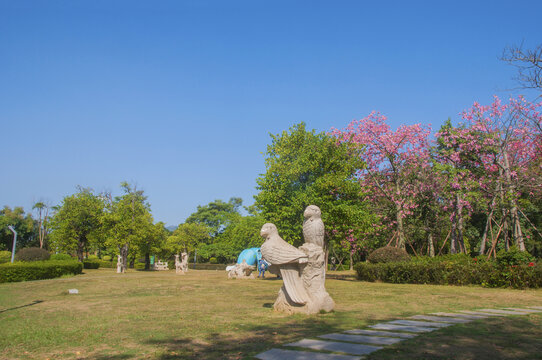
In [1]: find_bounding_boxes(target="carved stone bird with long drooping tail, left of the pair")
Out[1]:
[260,223,309,305]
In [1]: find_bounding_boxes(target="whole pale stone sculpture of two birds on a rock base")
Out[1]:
[260,205,335,314]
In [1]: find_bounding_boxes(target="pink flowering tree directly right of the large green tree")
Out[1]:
[332,112,430,248]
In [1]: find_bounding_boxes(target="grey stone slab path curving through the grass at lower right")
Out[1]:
[256,306,542,360]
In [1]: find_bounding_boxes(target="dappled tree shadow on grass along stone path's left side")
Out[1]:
[142,316,350,360]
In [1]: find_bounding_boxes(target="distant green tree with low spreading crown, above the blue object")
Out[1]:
[186,197,243,237]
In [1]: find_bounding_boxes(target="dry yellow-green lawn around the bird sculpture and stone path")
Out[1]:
[0,269,542,360]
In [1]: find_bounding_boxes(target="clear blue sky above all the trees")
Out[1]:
[0,0,542,225]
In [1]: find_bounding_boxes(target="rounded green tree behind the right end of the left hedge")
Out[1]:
[50,187,104,261]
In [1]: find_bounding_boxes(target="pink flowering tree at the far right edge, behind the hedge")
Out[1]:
[437,97,542,254]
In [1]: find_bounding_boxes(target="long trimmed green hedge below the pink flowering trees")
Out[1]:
[354,261,542,289]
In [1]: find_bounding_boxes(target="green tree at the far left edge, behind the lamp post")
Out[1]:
[0,206,36,251]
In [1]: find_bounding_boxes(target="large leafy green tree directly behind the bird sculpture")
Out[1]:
[255,123,371,252]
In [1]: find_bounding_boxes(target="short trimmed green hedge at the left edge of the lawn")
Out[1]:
[0,260,83,283]
